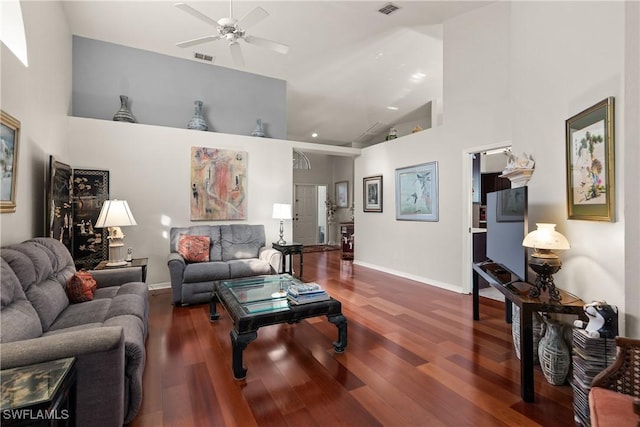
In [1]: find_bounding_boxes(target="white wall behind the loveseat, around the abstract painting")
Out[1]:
[66,117,293,284]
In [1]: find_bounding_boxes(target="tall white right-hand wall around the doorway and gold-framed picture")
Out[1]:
[355,2,638,332]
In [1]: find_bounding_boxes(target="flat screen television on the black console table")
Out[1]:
[487,187,529,281]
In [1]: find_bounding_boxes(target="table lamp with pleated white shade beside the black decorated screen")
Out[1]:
[94,200,137,267]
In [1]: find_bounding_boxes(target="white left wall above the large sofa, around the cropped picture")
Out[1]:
[0,2,71,245]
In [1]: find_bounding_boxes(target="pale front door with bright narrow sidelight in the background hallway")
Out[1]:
[293,184,327,245]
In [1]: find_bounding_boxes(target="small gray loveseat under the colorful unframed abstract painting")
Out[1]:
[167,224,282,305]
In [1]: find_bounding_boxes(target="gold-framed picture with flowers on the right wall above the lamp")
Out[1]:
[566,97,615,222]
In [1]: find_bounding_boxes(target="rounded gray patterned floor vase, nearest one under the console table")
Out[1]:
[538,319,571,385]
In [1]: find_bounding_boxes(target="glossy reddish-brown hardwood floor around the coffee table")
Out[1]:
[131,251,575,427]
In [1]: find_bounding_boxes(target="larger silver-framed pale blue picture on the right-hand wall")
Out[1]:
[396,162,438,221]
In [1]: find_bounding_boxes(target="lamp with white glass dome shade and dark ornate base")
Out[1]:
[522,223,570,301]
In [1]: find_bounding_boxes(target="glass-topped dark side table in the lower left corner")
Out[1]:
[0,357,77,426]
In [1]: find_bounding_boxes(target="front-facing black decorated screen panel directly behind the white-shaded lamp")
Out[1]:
[71,169,109,270]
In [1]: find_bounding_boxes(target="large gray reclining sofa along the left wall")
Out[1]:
[0,237,149,426]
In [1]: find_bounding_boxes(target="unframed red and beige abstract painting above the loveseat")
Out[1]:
[190,147,248,221]
